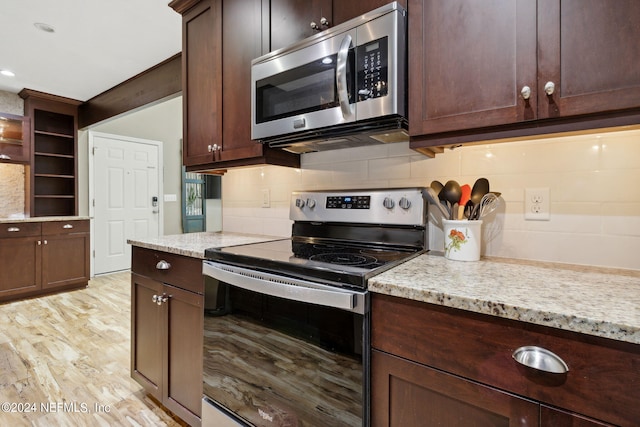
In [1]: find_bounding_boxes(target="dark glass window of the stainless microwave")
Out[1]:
[256,49,355,123]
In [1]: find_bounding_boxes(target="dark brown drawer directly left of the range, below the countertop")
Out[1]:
[131,246,204,294]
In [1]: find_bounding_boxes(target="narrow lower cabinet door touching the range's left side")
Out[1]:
[162,286,204,425]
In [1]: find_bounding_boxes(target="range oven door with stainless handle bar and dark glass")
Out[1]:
[202,261,369,427]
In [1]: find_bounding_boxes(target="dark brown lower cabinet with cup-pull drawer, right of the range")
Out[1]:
[371,294,640,427]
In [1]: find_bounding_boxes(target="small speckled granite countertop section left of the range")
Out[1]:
[127,232,283,259]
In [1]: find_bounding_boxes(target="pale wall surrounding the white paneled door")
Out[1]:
[78,96,189,234]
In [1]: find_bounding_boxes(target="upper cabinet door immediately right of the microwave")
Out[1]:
[408,0,537,135]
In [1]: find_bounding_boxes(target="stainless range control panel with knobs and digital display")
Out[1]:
[289,187,427,226]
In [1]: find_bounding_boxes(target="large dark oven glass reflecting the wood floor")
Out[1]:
[203,281,364,427]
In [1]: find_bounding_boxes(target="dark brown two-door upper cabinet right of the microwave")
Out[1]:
[408,0,640,148]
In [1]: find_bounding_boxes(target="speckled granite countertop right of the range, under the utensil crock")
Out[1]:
[368,255,640,344]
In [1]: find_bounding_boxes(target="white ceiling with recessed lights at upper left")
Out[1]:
[0,0,182,101]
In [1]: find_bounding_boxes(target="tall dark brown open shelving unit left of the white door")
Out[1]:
[20,89,81,217]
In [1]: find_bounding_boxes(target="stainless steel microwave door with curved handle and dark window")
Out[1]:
[251,30,356,139]
